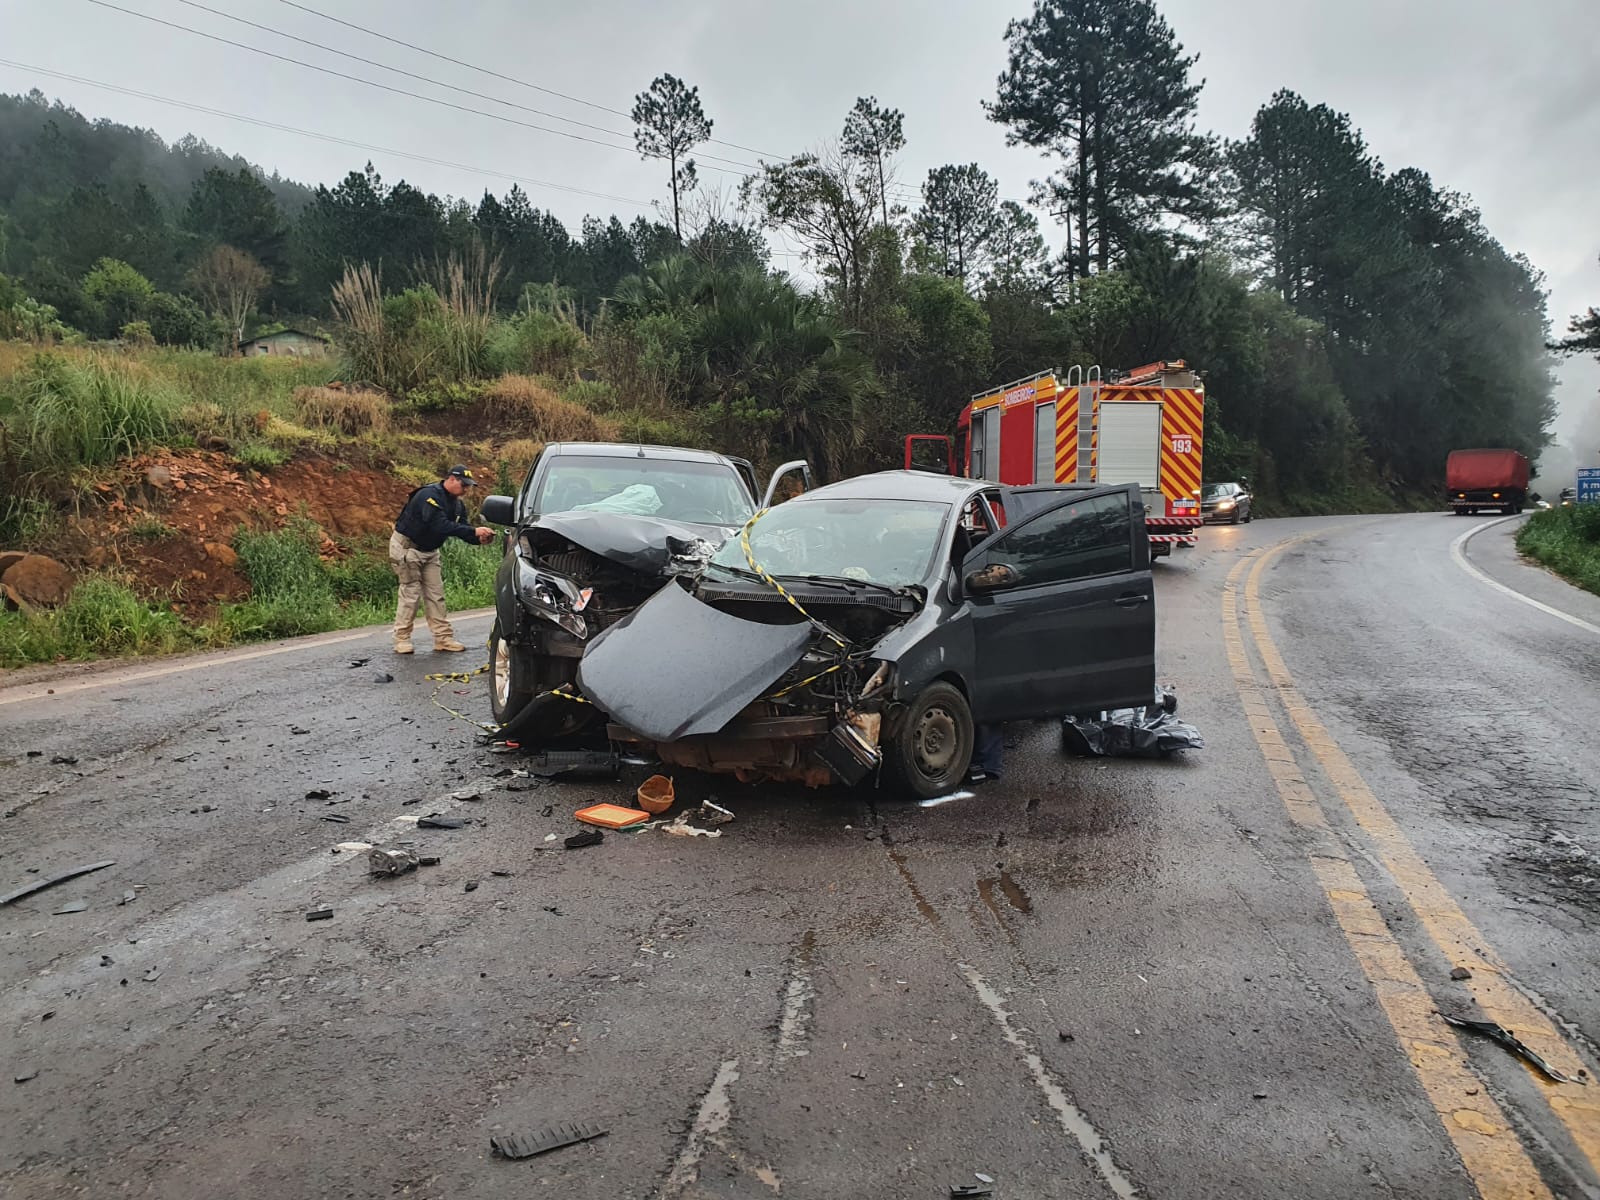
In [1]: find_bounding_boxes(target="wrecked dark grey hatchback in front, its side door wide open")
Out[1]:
[480,454,1155,798]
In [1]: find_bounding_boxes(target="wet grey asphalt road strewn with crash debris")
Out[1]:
[0,515,1600,1200]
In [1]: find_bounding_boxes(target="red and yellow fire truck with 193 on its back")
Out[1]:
[906,358,1205,557]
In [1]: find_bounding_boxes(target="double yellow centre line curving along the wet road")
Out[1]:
[1222,534,1600,1200]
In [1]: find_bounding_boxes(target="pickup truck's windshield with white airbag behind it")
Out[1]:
[533,454,752,525]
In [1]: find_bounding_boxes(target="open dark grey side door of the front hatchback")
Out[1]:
[962,485,1155,722]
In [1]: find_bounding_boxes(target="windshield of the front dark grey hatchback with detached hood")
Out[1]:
[712,499,950,587]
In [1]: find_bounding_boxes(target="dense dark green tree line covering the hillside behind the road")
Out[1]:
[0,0,1555,501]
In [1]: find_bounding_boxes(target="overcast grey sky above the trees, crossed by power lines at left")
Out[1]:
[0,0,1600,453]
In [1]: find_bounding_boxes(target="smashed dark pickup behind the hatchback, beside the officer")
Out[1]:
[470,442,810,742]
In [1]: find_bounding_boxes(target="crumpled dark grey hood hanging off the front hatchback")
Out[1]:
[568,582,811,742]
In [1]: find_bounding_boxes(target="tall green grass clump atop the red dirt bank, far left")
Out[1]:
[16,354,182,470]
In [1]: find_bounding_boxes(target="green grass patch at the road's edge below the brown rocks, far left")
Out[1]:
[0,576,194,667]
